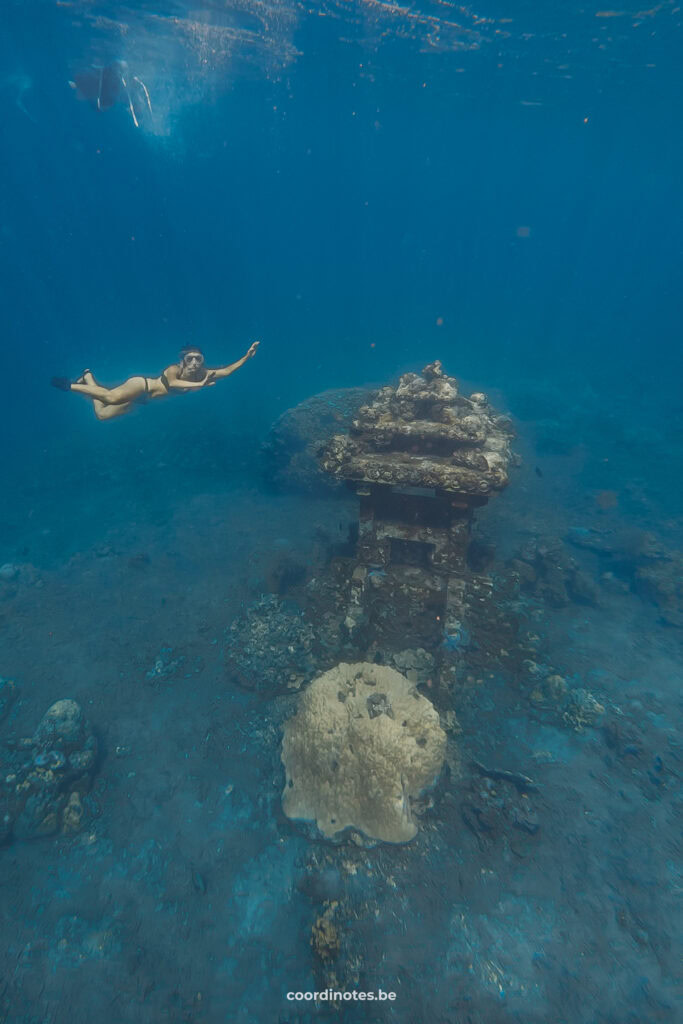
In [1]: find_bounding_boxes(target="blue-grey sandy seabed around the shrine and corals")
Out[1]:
[0,411,681,1024]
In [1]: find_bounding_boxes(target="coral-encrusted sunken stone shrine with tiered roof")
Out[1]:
[319,361,512,659]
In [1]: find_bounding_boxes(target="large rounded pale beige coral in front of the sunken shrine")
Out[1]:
[282,662,445,843]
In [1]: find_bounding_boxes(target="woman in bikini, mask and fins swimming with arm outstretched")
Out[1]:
[50,341,259,420]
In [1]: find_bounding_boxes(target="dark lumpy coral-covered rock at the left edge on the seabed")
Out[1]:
[0,700,97,841]
